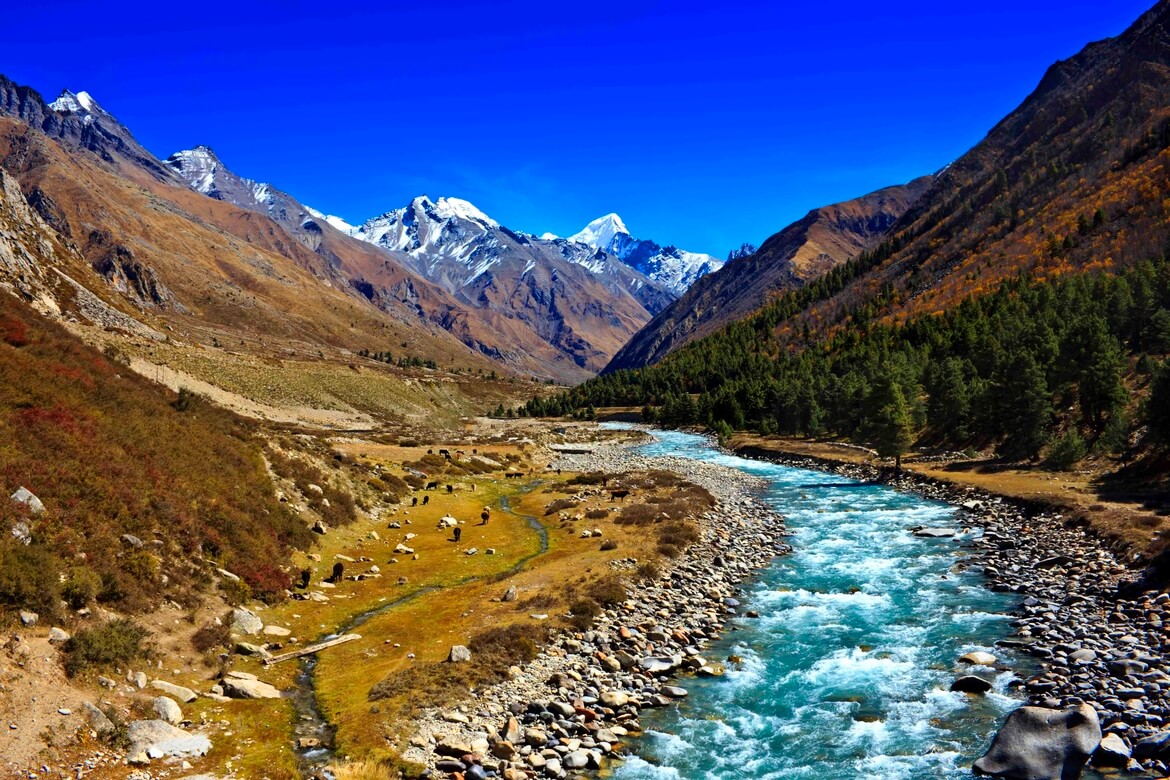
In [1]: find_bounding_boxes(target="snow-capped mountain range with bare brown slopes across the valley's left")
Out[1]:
[0,84,718,381]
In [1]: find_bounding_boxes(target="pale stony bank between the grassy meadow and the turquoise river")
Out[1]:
[404,444,790,780]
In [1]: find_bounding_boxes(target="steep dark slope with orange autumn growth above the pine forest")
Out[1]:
[779,0,1170,343]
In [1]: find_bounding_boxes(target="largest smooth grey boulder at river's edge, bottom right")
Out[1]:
[973,704,1101,780]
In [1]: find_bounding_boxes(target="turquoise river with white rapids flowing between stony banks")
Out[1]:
[614,432,1027,780]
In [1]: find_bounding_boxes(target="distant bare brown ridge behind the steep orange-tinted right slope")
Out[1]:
[607,177,931,371]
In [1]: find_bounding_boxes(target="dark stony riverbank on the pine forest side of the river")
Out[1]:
[741,448,1170,776]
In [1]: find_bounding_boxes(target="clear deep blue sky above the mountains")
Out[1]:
[0,0,1152,256]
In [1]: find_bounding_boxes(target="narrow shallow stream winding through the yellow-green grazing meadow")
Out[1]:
[289,481,549,778]
